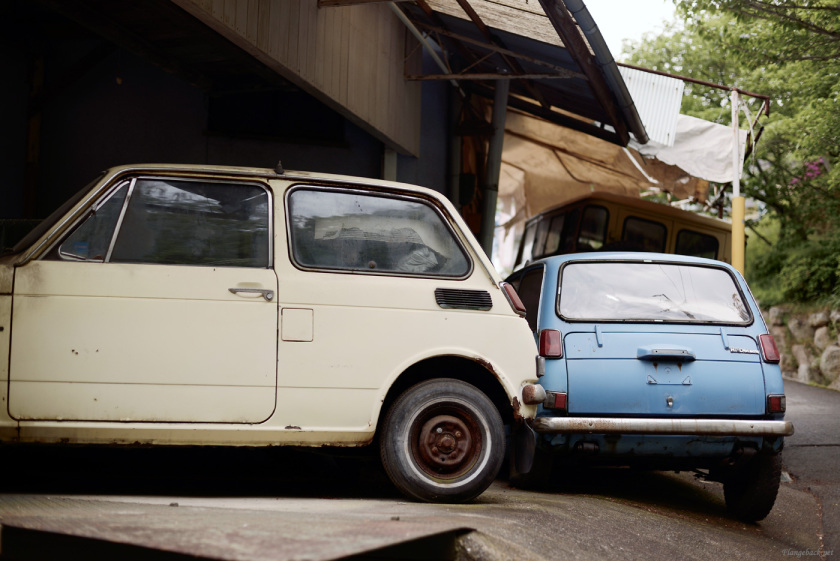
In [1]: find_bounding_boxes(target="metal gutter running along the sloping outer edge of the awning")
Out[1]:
[562,0,650,144]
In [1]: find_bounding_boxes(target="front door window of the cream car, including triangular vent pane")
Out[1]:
[48,178,271,267]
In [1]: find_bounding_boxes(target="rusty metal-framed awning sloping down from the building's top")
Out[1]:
[354,0,647,146]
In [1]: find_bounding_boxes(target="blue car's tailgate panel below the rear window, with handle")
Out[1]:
[565,325,765,417]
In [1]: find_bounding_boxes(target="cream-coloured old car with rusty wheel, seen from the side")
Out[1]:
[0,165,544,501]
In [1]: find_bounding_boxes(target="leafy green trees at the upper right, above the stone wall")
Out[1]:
[624,0,840,305]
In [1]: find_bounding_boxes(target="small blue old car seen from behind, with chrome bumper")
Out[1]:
[507,252,793,521]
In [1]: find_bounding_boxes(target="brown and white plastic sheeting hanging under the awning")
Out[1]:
[494,109,747,270]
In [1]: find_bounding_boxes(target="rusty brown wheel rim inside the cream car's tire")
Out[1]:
[410,407,482,479]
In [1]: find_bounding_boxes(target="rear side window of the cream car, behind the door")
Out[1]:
[287,189,471,277]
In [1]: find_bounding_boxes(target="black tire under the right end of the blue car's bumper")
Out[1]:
[723,454,782,522]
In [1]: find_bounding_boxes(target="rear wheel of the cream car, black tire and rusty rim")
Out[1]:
[379,378,505,503]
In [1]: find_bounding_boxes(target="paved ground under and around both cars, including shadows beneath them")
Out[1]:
[0,382,840,561]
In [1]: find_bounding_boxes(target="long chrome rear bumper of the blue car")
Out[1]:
[533,417,793,436]
